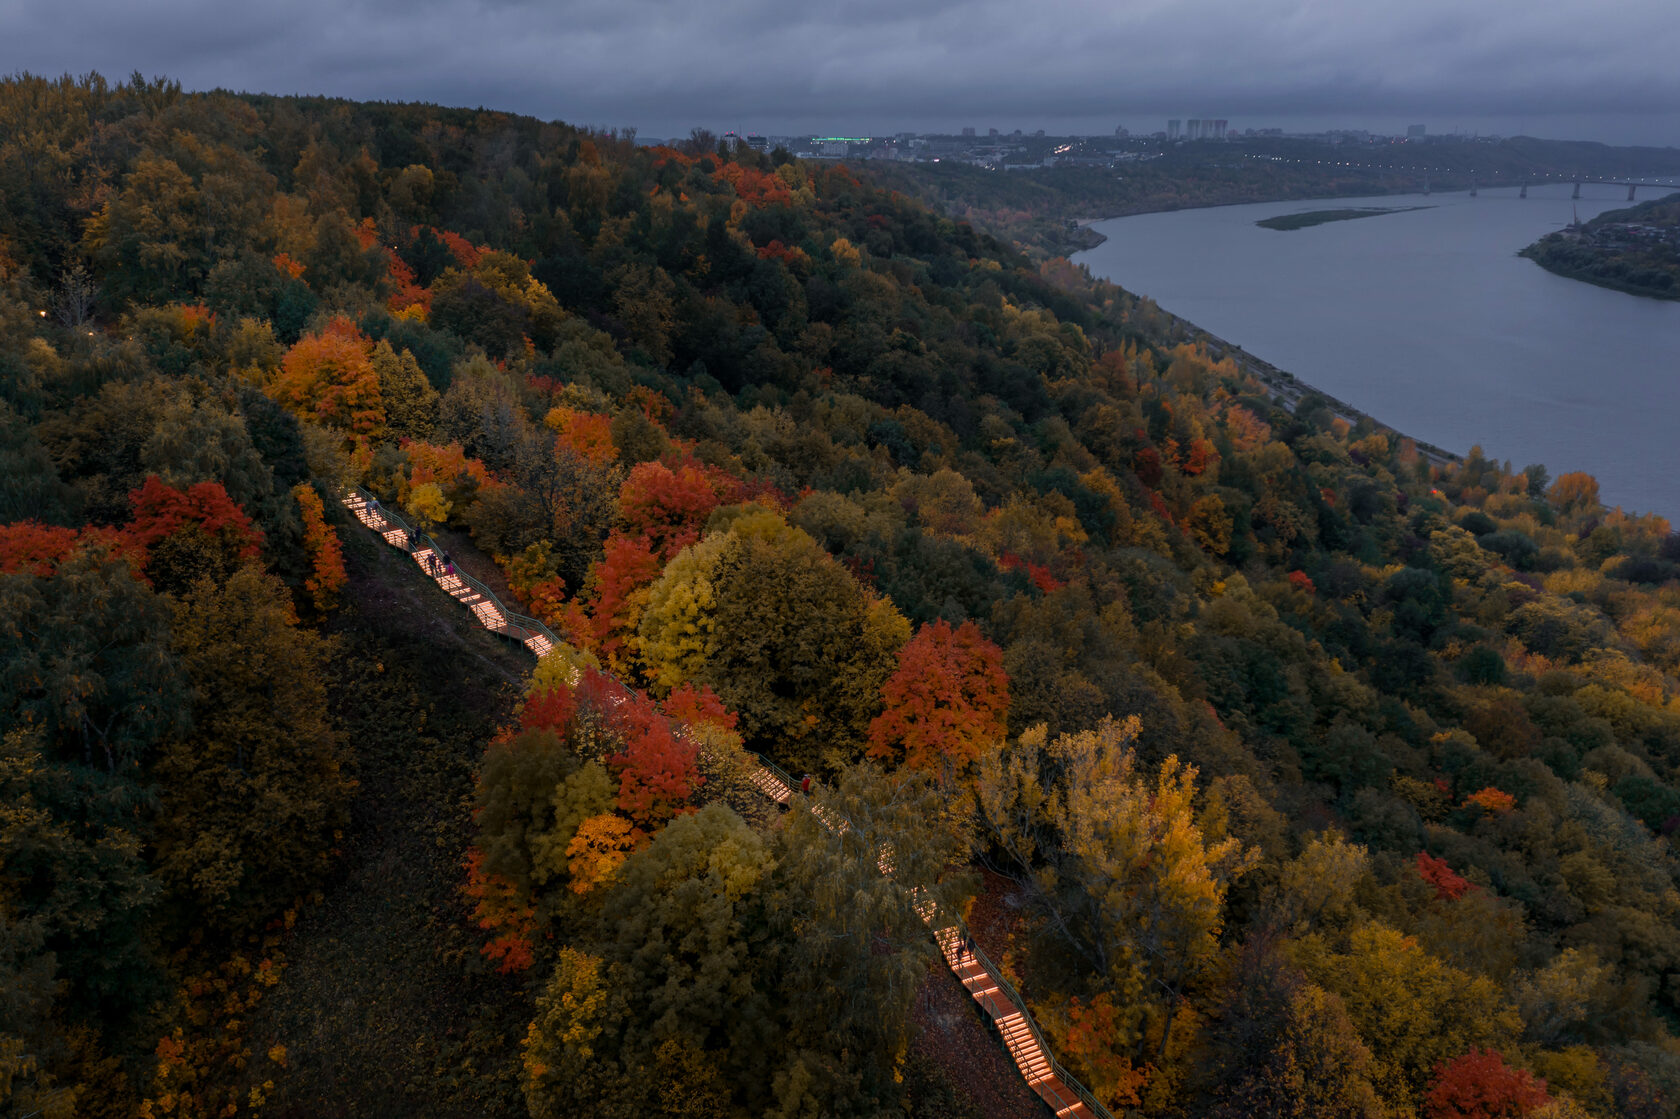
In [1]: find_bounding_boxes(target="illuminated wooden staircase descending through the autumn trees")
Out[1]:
[343,489,1114,1119]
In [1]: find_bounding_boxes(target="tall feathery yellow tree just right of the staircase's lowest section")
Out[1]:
[976,716,1257,1080]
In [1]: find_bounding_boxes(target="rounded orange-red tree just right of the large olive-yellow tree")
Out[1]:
[869,618,1010,776]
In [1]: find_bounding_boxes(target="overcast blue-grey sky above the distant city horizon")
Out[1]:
[0,0,1680,146]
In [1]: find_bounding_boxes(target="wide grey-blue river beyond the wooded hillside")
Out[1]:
[1075,185,1680,524]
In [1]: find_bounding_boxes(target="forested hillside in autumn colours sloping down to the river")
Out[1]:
[0,76,1680,1119]
